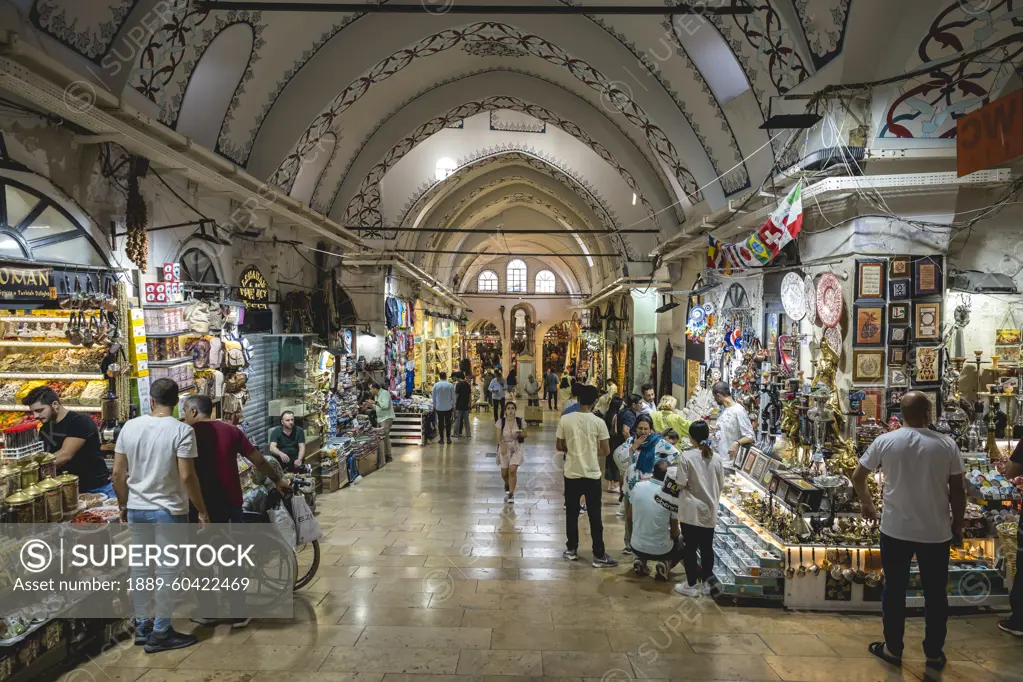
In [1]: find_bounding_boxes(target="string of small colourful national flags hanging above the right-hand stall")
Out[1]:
[707,182,803,272]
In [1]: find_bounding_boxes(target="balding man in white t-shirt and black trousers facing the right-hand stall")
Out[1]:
[852,391,966,670]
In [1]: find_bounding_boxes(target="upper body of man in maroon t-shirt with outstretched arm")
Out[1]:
[182,395,288,524]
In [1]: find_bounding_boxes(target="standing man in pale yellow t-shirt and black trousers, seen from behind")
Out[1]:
[558,385,618,569]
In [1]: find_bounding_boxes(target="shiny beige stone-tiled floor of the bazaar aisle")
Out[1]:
[74,413,1023,682]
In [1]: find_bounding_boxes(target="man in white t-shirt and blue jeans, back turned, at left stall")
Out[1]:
[114,379,210,653]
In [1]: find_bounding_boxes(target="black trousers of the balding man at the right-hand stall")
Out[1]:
[881,533,951,658]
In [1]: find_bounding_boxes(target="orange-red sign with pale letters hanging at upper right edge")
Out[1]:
[955,90,1023,178]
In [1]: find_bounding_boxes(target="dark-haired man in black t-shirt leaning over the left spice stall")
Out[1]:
[21,387,115,498]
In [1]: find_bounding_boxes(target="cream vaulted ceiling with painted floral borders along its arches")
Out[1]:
[10,0,1023,290]
